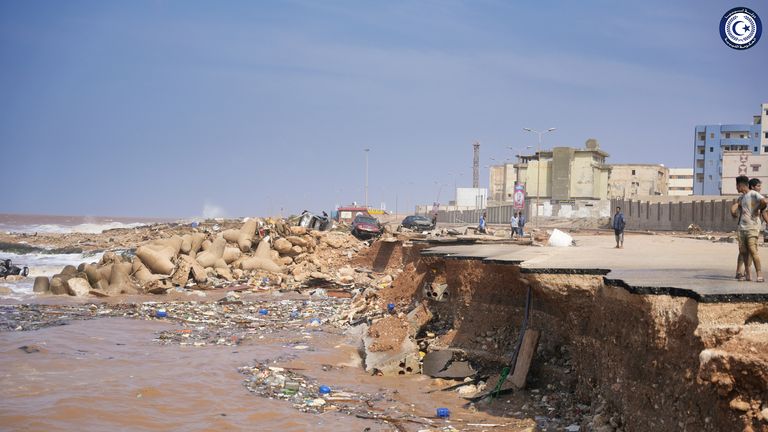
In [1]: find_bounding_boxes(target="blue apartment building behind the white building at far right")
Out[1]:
[693,103,768,195]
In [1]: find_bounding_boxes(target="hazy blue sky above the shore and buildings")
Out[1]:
[0,0,768,217]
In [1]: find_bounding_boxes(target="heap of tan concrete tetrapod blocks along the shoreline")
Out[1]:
[35,218,366,296]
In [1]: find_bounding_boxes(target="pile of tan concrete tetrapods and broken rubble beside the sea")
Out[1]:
[34,218,371,297]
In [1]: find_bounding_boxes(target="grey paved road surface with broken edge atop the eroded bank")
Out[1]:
[422,234,768,302]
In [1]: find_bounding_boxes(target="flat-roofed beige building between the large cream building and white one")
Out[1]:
[608,164,669,199]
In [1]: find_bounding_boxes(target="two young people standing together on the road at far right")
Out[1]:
[731,175,768,282]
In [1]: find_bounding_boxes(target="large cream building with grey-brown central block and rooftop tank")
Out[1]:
[490,139,610,202]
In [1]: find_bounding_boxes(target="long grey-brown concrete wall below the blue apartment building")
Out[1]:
[611,197,737,232]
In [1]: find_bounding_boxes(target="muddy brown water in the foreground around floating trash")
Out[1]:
[0,318,510,431]
